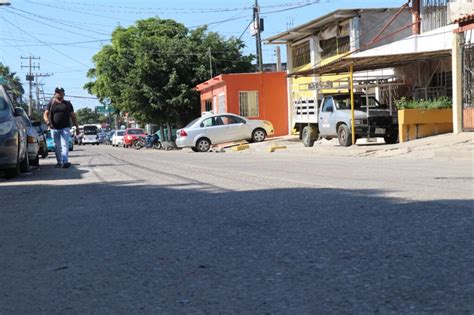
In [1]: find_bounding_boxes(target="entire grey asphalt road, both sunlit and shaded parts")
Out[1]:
[0,146,474,314]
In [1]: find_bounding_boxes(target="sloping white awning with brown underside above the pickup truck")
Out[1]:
[290,24,464,77]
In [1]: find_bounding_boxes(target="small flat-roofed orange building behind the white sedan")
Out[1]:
[196,72,288,136]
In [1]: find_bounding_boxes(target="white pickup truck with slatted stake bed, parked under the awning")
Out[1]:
[295,93,398,147]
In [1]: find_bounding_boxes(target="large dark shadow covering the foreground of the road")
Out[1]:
[0,181,474,314]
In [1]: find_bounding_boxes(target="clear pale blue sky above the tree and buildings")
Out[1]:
[0,0,406,109]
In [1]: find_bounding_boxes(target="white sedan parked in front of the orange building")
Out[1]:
[176,113,274,152]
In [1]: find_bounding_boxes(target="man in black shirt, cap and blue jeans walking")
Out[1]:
[43,87,79,168]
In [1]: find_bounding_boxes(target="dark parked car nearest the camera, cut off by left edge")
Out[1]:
[0,85,30,178]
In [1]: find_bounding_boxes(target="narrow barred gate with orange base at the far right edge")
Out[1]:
[462,44,474,131]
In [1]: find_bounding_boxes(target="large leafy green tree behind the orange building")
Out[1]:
[85,18,254,125]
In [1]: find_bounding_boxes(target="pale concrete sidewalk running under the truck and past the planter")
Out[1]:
[235,132,474,161]
